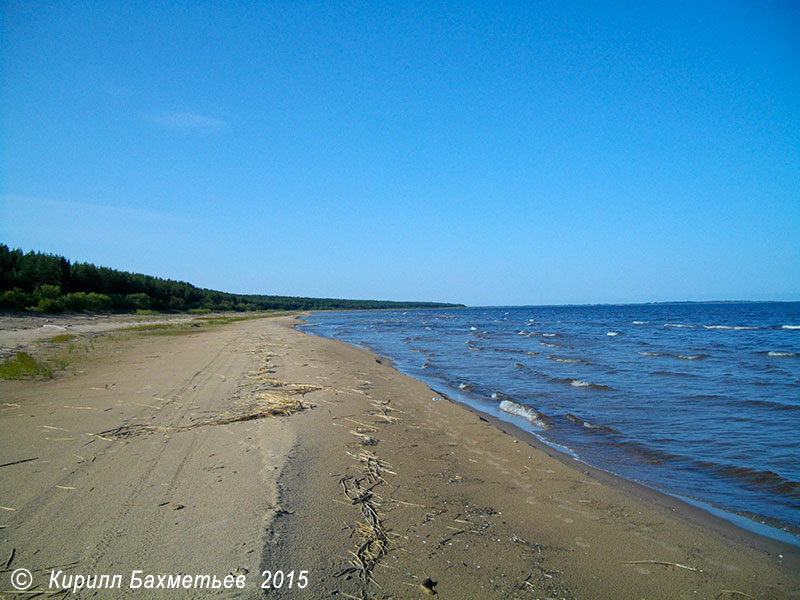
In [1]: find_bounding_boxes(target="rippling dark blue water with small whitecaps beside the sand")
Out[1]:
[301,303,800,544]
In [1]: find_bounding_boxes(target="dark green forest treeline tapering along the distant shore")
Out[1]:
[0,244,457,313]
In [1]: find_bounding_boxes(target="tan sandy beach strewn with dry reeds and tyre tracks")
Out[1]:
[0,316,800,599]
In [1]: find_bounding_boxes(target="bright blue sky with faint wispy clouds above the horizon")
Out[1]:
[0,0,800,305]
